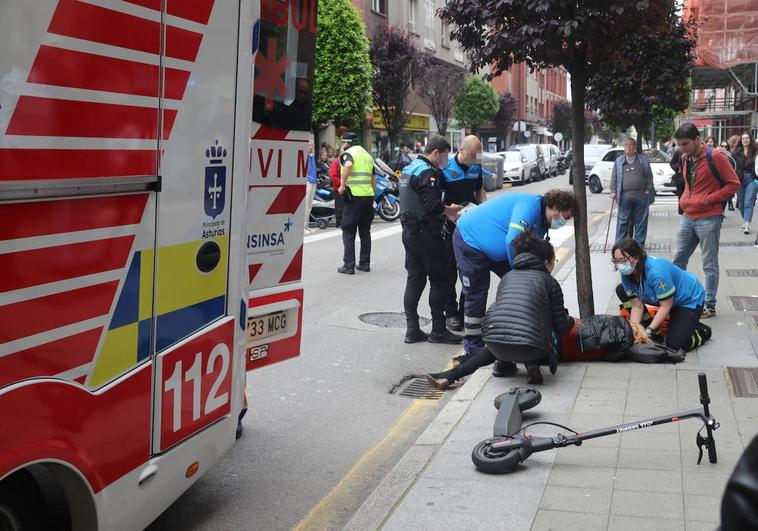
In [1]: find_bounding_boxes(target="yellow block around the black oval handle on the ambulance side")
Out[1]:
[156,236,228,315]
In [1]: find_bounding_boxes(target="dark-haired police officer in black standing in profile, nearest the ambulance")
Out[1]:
[400,136,461,344]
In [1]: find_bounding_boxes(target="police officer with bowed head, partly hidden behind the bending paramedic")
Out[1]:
[442,135,490,331]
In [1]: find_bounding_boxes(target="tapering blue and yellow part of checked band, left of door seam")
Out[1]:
[88,249,153,387]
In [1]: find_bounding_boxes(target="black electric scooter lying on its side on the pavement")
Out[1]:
[471,372,719,474]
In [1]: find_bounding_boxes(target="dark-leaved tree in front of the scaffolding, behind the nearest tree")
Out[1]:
[587,5,695,150]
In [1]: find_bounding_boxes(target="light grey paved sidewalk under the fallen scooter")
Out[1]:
[345,198,758,531]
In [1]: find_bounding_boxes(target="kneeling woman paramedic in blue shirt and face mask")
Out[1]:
[612,238,705,351]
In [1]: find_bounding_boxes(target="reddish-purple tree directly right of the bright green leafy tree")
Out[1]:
[369,25,428,149]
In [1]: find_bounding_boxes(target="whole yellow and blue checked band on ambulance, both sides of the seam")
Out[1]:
[89,236,228,387]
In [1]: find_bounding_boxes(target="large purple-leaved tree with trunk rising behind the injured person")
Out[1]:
[440,0,674,317]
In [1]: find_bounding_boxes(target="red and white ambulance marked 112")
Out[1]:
[0,0,316,530]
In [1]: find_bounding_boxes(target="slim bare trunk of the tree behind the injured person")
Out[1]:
[571,74,595,318]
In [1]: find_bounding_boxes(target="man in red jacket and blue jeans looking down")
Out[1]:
[674,124,740,318]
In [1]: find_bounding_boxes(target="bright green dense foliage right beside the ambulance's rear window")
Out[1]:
[312,0,373,128]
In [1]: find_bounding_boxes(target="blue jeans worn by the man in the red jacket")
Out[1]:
[674,214,722,308]
